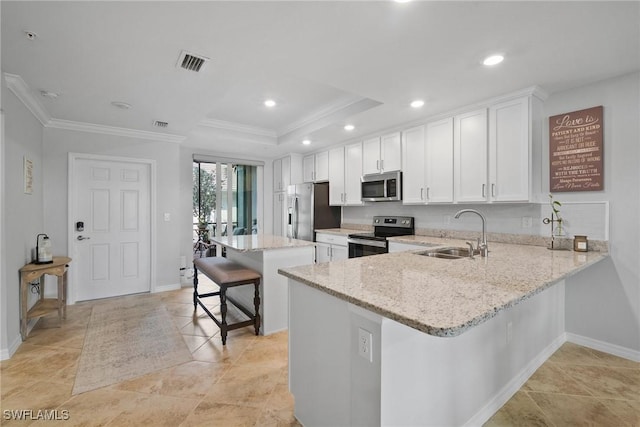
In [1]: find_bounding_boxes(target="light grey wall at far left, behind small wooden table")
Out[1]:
[0,78,45,359]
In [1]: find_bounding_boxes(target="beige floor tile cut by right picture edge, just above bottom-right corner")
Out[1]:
[562,365,640,400]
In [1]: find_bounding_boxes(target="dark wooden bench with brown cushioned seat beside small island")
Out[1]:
[193,257,260,345]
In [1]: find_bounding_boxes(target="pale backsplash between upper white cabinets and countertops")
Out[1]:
[342,202,609,240]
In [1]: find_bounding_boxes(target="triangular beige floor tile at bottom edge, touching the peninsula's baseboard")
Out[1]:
[484,391,553,427]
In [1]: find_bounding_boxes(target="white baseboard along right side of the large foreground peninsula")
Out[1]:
[464,333,567,427]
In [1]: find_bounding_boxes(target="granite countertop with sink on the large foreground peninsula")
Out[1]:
[278,241,608,336]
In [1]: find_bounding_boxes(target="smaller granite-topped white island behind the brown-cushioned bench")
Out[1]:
[211,234,315,335]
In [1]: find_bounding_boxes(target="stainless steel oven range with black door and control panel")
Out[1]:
[347,216,415,258]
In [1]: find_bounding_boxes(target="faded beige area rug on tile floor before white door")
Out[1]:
[73,298,193,395]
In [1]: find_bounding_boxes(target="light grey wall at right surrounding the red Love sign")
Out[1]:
[543,73,640,351]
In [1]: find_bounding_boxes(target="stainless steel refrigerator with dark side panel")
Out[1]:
[286,182,342,242]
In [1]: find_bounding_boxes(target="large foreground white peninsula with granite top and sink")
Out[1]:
[280,242,607,426]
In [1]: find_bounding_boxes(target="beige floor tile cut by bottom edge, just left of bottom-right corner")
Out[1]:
[528,392,623,427]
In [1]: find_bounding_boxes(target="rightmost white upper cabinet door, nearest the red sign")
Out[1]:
[489,98,531,202]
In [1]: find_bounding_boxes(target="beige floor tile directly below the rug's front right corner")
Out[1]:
[112,361,230,399]
